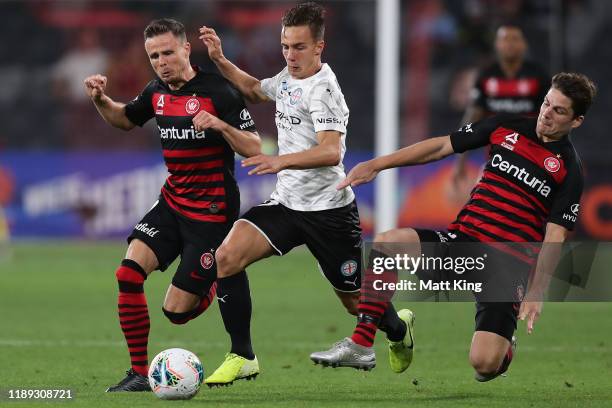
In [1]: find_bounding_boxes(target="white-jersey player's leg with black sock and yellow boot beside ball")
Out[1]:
[205,220,274,387]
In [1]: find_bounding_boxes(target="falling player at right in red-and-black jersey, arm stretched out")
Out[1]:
[311,73,596,381]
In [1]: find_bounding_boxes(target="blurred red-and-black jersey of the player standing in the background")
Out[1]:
[473,61,550,116]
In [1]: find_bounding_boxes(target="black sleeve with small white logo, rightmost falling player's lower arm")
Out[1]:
[548,163,584,231]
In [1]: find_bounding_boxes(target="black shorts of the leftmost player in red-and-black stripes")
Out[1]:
[127,198,232,296]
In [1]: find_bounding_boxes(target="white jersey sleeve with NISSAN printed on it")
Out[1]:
[308,82,348,134]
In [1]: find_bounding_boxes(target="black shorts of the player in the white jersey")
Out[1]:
[238,200,361,292]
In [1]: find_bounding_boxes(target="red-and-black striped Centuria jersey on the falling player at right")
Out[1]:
[449,115,583,249]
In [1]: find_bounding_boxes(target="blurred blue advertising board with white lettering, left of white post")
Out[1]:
[0,151,373,239]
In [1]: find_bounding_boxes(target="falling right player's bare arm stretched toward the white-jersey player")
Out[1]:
[336,136,454,190]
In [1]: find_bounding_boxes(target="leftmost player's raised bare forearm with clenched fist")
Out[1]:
[83,74,135,130]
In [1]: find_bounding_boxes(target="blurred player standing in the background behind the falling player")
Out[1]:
[452,23,550,202]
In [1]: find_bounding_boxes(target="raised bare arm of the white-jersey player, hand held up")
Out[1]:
[199,26,270,103]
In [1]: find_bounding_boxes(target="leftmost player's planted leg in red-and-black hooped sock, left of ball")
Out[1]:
[106,239,158,392]
